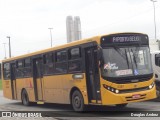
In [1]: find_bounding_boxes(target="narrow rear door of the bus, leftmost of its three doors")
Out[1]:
[10,63,17,99]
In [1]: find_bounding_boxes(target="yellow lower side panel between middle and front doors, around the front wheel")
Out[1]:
[43,74,88,104]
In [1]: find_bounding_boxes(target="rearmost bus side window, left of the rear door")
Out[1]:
[3,63,10,80]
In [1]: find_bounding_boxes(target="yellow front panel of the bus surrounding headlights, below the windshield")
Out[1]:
[101,78,157,105]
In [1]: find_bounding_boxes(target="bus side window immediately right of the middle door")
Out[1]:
[43,52,54,75]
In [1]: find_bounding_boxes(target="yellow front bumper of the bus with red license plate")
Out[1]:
[102,86,157,105]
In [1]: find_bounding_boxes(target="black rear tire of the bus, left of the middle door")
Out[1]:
[21,90,30,106]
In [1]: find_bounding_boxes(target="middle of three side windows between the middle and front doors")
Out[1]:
[55,50,68,73]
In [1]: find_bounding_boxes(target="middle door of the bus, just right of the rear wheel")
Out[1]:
[33,57,43,101]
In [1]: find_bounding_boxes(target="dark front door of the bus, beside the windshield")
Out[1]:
[85,47,101,103]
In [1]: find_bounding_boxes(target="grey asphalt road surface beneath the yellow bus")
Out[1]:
[0,91,160,120]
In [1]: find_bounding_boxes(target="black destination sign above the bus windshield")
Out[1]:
[101,33,149,46]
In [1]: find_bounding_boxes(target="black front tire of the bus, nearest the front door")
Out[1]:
[71,90,85,112]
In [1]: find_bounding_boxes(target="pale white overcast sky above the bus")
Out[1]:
[0,0,160,60]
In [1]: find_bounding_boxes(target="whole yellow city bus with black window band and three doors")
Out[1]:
[2,33,156,111]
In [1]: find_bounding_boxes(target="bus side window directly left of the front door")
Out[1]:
[68,47,82,73]
